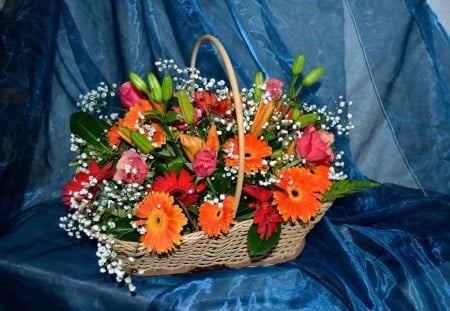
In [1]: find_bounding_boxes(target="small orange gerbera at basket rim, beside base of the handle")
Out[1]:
[198,195,234,237]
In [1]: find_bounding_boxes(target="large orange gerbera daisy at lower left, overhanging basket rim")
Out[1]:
[134,192,187,254]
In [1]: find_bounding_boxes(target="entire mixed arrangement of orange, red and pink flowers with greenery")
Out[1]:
[60,36,374,290]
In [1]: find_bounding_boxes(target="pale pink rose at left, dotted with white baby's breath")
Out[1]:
[113,150,148,184]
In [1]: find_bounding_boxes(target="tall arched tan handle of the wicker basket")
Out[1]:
[190,35,245,216]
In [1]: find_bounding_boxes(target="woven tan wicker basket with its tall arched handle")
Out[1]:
[114,35,331,275]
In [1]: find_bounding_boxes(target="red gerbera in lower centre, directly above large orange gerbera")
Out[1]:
[153,169,198,206]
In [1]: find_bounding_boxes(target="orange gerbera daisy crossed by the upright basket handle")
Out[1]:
[222,134,272,174]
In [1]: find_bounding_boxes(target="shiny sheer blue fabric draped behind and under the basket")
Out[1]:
[0,0,450,310]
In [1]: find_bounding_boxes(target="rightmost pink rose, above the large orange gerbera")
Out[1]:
[296,124,334,162]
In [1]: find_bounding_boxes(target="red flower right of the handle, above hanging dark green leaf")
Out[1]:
[242,185,283,240]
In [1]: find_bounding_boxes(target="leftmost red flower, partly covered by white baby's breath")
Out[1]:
[62,161,115,206]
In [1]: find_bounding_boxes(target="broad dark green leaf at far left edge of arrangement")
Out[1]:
[70,112,109,149]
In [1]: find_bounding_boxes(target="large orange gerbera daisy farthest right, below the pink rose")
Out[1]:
[273,167,322,222]
